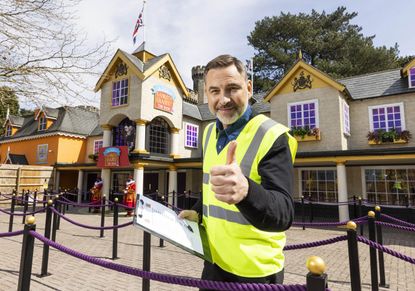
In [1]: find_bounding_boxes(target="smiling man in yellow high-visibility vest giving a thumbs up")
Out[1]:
[179,55,297,290]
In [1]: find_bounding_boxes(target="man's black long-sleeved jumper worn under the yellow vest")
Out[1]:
[192,107,294,231]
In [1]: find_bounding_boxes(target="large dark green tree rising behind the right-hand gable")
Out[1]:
[248,7,408,92]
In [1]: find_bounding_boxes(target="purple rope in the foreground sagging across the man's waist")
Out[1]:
[29,230,307,291]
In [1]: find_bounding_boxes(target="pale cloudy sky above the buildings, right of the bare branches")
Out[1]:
[77,0,415,106]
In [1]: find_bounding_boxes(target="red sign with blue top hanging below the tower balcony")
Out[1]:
[98,146,130,168]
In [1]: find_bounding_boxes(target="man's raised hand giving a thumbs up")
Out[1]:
[210,141,249,204]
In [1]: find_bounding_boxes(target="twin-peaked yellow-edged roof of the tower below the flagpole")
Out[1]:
[94,49,190,96]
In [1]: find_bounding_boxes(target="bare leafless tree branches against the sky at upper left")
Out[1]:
[0,0,110,106]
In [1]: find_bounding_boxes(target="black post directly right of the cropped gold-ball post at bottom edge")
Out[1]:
[347,221,362,291]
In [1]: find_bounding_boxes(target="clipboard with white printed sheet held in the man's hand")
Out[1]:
[134,195,212,262]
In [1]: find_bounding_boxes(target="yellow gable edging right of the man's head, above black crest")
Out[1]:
[264,59,350,102]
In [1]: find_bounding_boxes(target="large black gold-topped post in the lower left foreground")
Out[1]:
[17,216,36,291]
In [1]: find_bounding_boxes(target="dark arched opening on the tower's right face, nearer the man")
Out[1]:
[147,117,170,155]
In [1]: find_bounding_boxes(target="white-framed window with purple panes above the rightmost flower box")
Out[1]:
[369,103,406,132]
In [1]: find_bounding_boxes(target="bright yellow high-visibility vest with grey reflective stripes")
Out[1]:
[202,115,297,278]
